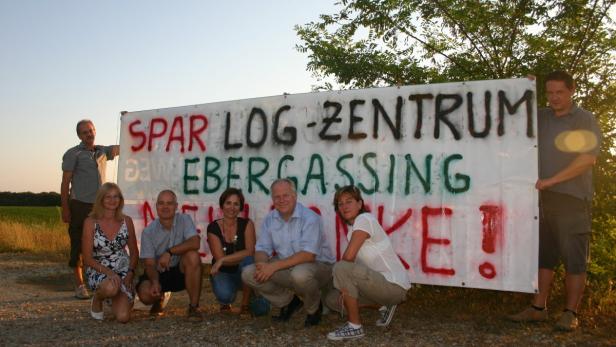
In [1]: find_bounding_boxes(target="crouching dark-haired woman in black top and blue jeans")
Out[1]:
[207,188,256,313]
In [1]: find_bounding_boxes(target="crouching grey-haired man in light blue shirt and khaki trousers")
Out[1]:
[242,179,335,327]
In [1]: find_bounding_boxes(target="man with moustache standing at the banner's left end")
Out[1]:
[60,119,120,299]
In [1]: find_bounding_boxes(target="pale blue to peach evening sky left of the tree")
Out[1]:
[0,0,334,192]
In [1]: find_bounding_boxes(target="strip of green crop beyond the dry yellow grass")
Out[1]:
[0,206,62,227]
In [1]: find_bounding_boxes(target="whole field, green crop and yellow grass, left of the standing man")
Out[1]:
[0,206,70,256]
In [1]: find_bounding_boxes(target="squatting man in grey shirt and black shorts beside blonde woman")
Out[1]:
[137,190,202,319]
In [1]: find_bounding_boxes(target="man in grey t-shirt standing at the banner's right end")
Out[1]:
[509,71,601,331]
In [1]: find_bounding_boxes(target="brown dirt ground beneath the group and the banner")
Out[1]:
[0,253,616,346]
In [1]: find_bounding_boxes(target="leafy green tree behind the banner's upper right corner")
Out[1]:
[295,0,616,302]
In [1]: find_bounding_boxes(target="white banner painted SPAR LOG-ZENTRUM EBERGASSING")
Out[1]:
[118,79,538,292]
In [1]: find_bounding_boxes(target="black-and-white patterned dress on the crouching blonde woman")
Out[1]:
[86,221,134,301]
